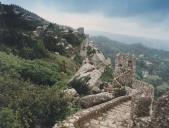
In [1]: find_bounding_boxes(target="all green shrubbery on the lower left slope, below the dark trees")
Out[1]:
[0,52,75,128]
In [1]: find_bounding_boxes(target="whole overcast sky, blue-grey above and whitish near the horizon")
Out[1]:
[0,0,169,40]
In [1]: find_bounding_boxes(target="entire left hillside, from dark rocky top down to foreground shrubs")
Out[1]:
[0,4,86,128]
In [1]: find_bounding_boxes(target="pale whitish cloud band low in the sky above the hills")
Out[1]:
[33,7,169,40]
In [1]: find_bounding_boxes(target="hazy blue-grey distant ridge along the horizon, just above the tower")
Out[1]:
[91,36,169,59]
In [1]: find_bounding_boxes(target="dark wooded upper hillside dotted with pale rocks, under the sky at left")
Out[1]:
[0,4,84,59]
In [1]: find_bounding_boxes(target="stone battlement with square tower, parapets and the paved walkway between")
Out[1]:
[53,54,154,128]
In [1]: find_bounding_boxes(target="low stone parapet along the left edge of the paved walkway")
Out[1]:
[53,96,131,128]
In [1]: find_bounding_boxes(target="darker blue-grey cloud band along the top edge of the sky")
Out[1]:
[47,0,169,18]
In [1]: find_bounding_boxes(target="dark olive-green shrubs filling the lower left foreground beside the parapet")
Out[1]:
[0,74,73,128]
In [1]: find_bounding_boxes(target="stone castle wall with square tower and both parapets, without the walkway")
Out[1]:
[53,54,155,128]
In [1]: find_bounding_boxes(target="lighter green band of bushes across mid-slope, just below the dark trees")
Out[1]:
[0,52,75,85]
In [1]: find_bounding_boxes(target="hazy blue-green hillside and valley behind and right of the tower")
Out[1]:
[91,36,169,96]
